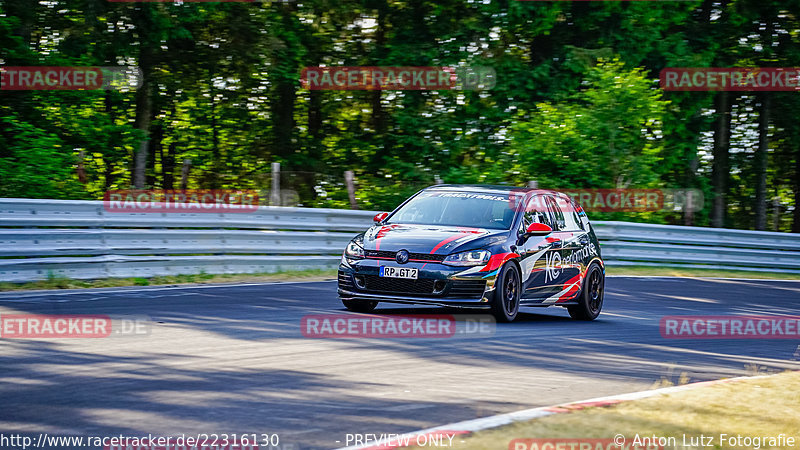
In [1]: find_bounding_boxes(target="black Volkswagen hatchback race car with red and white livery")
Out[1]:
[338,185,605,322]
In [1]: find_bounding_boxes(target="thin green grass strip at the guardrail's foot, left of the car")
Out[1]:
[0,269,336,291]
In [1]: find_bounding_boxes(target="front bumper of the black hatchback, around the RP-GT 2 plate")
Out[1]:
[338,259,496,308]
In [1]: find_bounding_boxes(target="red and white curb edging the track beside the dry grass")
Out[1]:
[337,375,770,450]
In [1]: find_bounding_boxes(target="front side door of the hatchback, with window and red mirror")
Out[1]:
[517,195,561,300]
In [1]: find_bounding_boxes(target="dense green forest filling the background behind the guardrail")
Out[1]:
[0,0,800,230]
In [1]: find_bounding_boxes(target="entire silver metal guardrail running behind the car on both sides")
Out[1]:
[0,199,800,281]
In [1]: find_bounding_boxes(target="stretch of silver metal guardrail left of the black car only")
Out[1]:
[0,199,374,281]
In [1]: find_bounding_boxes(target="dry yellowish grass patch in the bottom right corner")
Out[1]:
[414,372,800,450]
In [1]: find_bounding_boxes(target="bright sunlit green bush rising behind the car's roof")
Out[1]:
[506,59,668,189]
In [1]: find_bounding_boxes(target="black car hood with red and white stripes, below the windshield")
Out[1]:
[364,224,508,255]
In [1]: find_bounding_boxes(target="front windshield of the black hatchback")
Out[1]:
[388,191,514,230]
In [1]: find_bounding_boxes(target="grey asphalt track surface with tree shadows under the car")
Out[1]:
[0,277,800,449]
